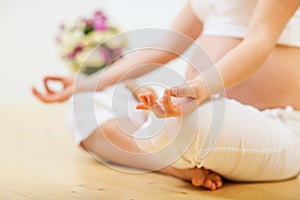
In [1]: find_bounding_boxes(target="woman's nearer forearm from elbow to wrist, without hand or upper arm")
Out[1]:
[203,37,275,95]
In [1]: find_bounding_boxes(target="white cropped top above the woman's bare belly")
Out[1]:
[191,0,300,47]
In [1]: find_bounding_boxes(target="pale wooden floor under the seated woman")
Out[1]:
[0,103,300,200]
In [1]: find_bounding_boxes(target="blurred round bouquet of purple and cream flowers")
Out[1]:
[57,11,126,75]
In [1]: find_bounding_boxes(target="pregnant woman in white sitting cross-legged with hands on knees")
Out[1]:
[33,0,300,190]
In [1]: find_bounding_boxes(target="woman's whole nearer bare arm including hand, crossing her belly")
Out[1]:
[138,0,300,117]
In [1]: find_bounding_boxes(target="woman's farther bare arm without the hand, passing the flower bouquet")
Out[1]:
[75,2,203,92]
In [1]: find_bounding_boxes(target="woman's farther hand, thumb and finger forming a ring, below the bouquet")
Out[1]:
[32,76,75,103]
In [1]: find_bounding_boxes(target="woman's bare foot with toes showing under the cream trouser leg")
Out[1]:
[161,167,223,190]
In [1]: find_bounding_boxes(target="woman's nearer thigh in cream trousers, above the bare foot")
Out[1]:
[198,98,300,181]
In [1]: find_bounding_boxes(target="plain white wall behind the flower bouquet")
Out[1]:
[0,0,185,103]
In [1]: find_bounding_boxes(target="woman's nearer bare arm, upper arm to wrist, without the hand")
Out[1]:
[199,0,300,96]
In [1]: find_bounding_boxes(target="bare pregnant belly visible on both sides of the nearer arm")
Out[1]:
[186,36,300,110]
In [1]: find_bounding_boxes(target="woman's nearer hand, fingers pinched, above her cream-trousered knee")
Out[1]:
[136,78,209,118]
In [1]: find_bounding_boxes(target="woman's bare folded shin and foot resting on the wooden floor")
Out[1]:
[81,119,223,190]
